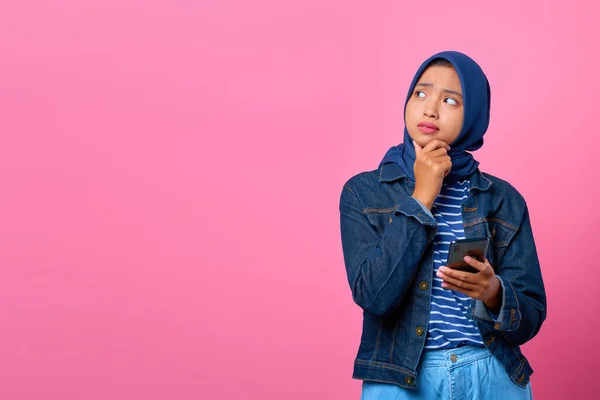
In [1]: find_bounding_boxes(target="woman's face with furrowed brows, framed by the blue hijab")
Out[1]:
[404,65,463,147]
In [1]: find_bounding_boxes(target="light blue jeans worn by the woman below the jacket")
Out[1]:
[361,346,533,400]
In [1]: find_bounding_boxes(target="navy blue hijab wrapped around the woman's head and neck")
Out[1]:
[379,51,491,183]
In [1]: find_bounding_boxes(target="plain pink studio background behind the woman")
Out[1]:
[0,0,600,400]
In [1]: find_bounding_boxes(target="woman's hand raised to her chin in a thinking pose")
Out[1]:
[412,139,452,210]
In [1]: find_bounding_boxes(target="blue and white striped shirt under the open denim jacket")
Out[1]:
[425,181,483,350]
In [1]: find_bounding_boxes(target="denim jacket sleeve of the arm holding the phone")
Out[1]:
[473,205,546,345]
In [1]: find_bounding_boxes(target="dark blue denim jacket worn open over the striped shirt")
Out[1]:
[339,163,546,388]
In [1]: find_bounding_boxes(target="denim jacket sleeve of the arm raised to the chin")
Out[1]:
[340,183,436,317]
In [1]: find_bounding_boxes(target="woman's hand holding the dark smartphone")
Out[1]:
[436,256,502,312]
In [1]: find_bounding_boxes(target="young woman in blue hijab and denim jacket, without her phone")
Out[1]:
[340,51,546,400]
